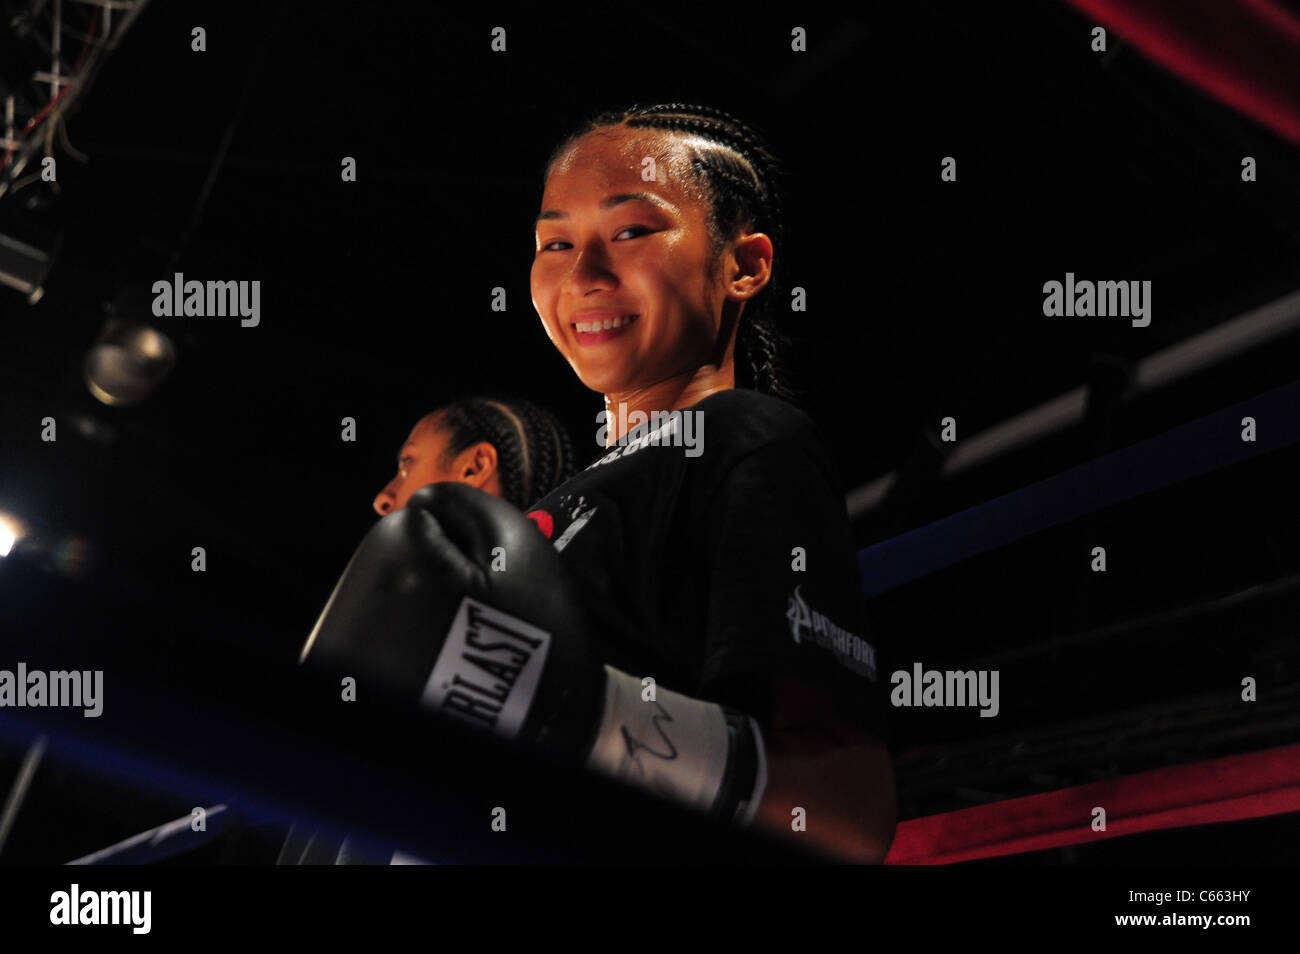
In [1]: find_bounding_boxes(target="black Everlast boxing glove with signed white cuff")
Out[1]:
[302,483,767,824]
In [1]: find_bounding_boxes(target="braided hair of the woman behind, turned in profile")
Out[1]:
[434,396,577,509]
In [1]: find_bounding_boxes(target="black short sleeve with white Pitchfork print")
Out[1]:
[698,441,889,742]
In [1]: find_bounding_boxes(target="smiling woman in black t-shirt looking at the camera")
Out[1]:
[517,104,896,862]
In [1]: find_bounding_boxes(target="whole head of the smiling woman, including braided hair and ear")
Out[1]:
[532,113,794,400]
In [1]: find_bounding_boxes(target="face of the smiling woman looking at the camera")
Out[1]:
[532,127,724,395]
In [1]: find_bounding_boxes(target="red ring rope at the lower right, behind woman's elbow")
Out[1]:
[885,745,1300,864]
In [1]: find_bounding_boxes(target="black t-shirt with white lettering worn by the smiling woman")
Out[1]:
[528,390,889,742]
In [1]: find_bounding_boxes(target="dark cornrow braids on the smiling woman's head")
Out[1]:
[543,103,801,403]
